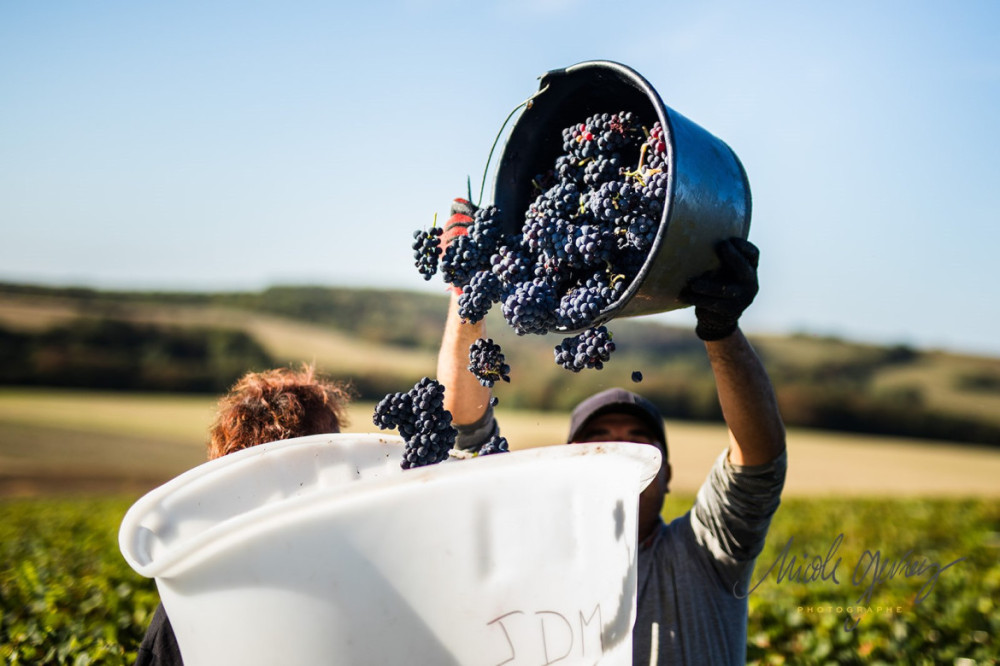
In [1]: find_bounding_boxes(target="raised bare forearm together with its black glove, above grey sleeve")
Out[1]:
[681,238,785,465]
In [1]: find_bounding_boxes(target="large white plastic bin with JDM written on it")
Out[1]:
[119,434,660,666]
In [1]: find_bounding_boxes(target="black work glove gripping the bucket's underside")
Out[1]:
[679,237,760,340]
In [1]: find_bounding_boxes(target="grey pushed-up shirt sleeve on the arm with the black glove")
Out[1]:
[691,450,788,594]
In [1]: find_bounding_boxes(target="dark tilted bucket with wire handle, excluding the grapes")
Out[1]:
[493,60,751,326]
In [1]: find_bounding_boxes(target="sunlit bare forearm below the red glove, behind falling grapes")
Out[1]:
[437,294,490,425]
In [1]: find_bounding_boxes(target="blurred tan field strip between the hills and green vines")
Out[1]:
[0,389,1000,497]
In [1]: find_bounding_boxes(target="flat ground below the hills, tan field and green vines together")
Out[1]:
[0,389,1000,664]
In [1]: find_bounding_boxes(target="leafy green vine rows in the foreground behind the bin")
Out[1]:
[0,495,1000,666]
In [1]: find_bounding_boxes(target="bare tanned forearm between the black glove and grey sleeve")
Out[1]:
[705,329,785,465]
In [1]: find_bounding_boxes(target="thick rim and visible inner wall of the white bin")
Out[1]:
[118,433,661,578]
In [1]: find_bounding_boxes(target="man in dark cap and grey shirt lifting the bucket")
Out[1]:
[437,202,786,664]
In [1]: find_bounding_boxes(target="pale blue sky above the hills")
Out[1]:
[0,0,1000,355]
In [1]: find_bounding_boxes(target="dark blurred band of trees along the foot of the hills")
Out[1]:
[0,318,1000,444]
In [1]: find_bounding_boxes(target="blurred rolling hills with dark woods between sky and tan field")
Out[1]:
[0,284,1000,445]
